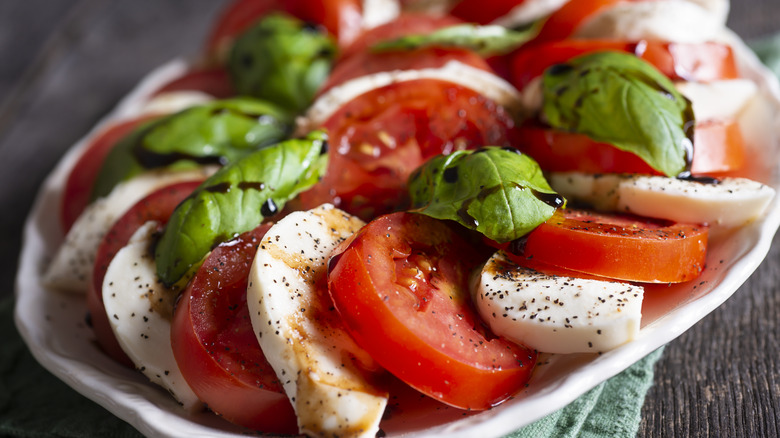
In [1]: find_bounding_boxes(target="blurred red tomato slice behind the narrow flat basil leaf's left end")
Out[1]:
[340,14,463,59]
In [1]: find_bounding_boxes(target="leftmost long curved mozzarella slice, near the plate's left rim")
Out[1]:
[42,167,214,293]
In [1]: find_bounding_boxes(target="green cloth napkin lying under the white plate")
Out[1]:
[0,298,661,438]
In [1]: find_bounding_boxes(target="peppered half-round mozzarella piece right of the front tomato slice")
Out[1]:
[474,251,644,353]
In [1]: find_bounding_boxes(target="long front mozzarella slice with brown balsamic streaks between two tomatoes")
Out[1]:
[247,204,387,437]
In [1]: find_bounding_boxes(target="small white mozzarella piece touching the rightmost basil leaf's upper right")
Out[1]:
[675,79,758,120]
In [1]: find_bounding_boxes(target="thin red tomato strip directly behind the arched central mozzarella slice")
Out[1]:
[319,47,493,94]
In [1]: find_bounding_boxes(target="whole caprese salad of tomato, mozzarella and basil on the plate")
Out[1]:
[44,0,775,437]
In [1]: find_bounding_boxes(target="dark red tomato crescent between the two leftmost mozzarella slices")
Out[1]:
[87,181,201,368]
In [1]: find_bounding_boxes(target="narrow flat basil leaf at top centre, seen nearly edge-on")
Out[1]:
[372,23,541,57]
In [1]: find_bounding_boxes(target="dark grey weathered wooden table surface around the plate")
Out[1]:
[0,0,780,437]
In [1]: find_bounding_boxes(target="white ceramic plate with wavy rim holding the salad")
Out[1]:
[15,35,780,438]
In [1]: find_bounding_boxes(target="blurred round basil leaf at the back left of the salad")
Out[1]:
[228,13,336,113]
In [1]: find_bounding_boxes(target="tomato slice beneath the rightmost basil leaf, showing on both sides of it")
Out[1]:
[517,120,745,175]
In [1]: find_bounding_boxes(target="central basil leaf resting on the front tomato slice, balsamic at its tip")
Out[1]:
[409,146,566,242]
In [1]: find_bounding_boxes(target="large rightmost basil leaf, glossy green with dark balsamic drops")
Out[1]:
[542,52,694,176]
